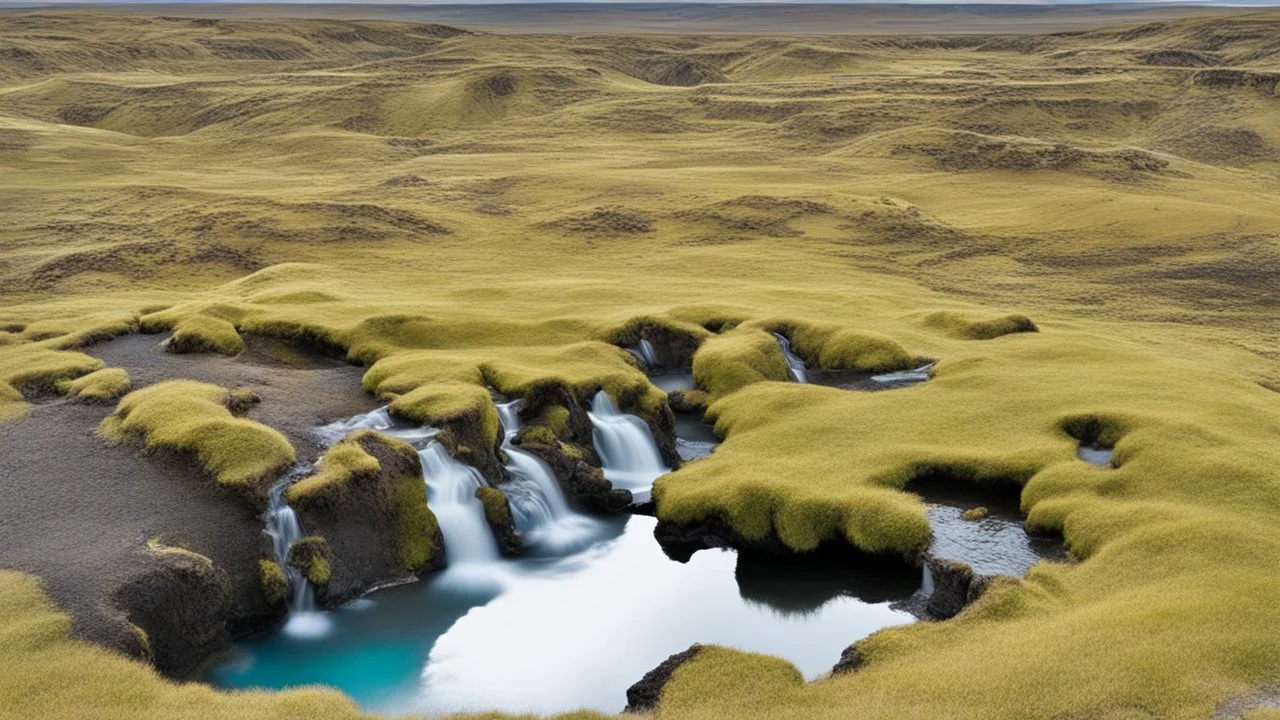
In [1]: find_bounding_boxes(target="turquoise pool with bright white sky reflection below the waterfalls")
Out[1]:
[209,516,918,714]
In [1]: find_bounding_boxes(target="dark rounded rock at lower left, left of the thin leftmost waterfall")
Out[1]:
[111,547,230,678]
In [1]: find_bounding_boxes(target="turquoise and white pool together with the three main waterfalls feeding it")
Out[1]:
[206,393,919,714]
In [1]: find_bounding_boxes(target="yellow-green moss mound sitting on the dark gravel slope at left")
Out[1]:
[101,380,294,489]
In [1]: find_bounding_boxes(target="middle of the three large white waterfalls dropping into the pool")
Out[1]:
[495,400,598,552]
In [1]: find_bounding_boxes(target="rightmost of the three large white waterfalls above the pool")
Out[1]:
[588,391,671,502]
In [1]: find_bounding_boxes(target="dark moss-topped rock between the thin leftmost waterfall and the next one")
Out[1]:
[284,430,444,607]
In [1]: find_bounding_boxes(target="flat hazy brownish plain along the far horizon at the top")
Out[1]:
[0,0,1266,35]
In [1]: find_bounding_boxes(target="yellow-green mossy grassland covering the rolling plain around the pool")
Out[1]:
[0,12,1280,720]
